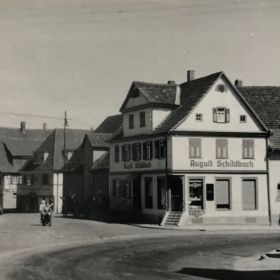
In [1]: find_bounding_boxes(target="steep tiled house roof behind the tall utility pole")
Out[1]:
[23,129,89,171]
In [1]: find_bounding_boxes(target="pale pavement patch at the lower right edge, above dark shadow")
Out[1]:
[234,249,280,272]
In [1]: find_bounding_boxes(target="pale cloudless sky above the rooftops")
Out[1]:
[0,0,280,129]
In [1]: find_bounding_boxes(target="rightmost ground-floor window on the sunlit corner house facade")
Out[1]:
[242,179,257,210]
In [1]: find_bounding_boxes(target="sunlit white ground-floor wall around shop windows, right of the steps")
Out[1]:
[185,174,268,220]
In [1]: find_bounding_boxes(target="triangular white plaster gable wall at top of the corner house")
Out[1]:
[175,79,259,132]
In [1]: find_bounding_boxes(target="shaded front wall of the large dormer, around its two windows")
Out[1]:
[123,109,152,136]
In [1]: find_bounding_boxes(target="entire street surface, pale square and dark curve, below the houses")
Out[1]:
[0,214,280,280]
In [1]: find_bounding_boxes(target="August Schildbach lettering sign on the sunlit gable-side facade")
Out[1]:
[190,159,254,169]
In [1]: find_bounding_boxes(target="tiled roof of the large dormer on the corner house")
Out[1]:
[120,81,177,112]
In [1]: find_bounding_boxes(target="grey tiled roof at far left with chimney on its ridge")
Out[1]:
[0,127,51,157]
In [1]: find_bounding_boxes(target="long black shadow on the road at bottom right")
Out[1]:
[176,267,280,280]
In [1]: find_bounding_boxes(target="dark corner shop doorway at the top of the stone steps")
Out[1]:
[169,176,183,211]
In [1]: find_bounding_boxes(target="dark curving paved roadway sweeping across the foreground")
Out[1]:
[4,234,280,280]
